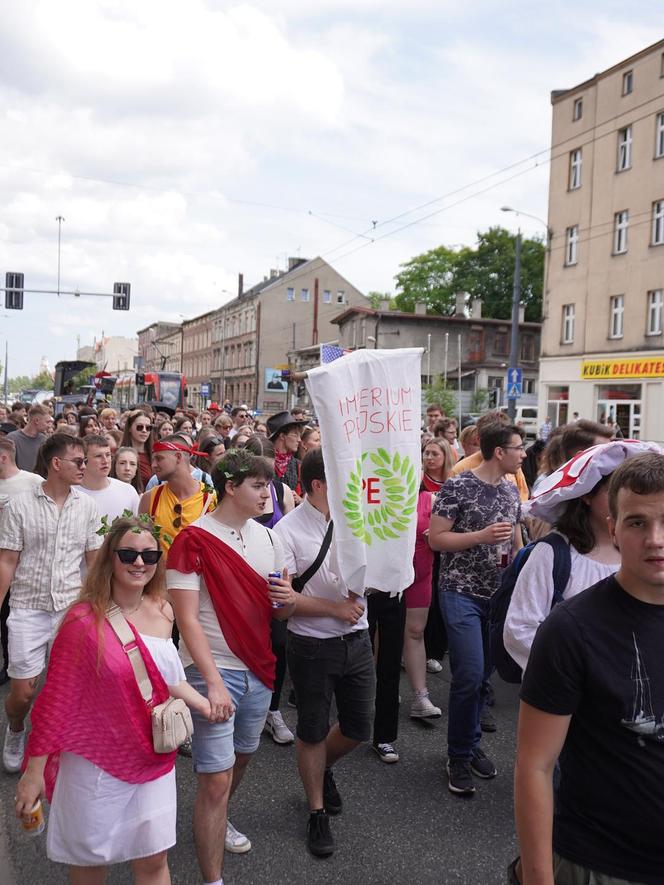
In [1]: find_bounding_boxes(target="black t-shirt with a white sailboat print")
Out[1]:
[521,577,664,885]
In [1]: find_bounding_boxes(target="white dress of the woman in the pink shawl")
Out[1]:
[46,634,185,866]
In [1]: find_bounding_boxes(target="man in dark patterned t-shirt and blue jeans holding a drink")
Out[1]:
[429,422,526,796]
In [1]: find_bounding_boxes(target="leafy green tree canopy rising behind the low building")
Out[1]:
[395,227,544,322]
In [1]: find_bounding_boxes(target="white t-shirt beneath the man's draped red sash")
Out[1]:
[166,513,284,670]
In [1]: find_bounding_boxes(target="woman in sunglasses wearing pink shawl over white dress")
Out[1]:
[16,517,210,885]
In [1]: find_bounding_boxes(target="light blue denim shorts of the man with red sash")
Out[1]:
[185,664,272,774]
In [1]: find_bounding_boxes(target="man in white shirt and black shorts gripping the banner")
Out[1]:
[274,449,376,857]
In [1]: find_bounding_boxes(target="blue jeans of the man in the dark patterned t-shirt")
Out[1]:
[439,591,491,760]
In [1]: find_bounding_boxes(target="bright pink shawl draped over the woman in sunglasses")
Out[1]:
[23,603,176,801]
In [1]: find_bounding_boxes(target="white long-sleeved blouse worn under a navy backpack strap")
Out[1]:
[503,544,620,670]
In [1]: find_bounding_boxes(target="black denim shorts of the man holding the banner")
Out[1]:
[287,630,376,744]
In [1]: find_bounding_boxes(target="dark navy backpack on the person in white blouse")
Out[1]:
[489,532,572,683]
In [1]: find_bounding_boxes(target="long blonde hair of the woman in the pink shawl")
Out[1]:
[78,516,166,630]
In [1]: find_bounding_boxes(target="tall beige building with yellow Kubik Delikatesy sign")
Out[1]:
[539,40,664,440]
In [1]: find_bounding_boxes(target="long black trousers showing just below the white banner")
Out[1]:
[367,593,406,744]
